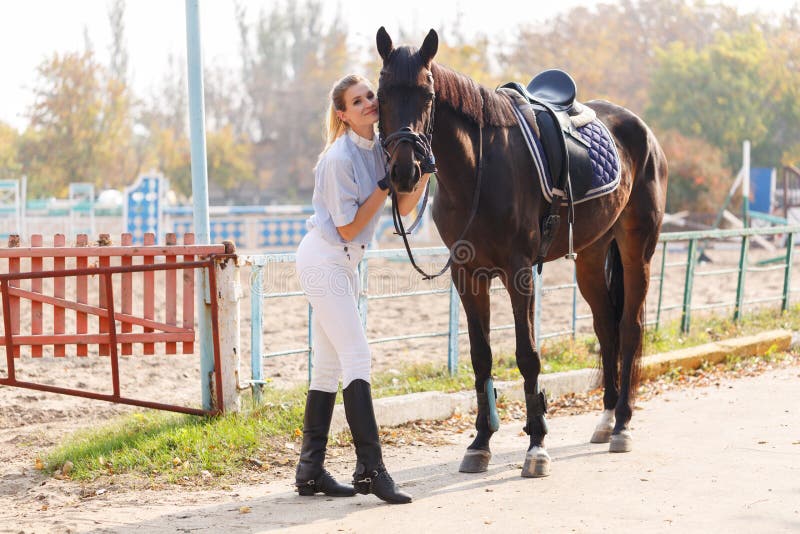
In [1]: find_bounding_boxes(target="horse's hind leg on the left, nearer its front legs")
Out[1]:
[576,239,619,443]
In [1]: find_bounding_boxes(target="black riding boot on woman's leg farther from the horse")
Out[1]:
[294,389,356,497]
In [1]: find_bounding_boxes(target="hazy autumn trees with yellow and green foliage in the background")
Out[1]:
[0,0,800,211]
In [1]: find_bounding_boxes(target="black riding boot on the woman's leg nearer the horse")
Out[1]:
[343,378,411,504]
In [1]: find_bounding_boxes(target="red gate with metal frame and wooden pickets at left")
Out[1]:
[0,234,231,415]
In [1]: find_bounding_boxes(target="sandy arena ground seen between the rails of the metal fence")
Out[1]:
[252,243,800,382]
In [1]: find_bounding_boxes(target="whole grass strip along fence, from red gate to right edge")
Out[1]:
[44,306,800,483]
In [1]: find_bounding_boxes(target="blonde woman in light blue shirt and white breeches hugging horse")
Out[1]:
[295,75,434,504]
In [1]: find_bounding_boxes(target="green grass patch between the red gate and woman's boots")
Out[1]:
[44,394,303,482]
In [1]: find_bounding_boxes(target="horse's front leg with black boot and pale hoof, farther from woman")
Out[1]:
[506,264,550,477]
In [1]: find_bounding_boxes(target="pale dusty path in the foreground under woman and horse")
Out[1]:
[0,355,800,533]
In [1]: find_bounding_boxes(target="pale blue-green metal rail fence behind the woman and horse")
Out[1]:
[240,225,800,399]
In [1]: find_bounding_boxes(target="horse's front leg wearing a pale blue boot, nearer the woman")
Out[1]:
[452,267,497,473]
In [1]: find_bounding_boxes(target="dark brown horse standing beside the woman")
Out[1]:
[377,28,667,482]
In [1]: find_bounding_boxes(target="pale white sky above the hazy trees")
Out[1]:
[0,0,800,129]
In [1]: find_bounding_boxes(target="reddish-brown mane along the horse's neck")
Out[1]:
[431,63,517,127]
